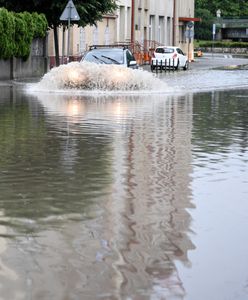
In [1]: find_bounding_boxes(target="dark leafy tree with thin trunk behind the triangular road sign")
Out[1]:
[0,0,117,65]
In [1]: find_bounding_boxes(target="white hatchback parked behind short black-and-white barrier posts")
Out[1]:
[151,46,189,71]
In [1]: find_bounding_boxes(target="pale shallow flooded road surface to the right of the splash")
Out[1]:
[144,53,248,93]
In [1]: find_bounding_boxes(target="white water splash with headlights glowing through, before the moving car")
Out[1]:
[32,62,168,91]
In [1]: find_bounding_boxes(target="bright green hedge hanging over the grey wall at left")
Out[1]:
[0,8,47,59]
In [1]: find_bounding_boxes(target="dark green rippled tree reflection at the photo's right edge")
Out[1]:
[193,90,248,152]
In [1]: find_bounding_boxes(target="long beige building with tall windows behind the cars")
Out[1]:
[49,0,196,65]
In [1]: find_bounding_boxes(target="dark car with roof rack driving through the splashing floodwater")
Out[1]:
[81,46,138,69]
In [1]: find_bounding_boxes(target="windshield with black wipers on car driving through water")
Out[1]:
[84,49,124,64]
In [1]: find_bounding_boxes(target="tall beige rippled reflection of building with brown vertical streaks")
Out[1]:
[101,96,196,299]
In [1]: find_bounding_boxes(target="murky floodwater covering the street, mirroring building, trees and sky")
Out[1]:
[0,62,248,300]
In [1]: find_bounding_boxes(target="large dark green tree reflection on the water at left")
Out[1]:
[0,92,111,233]
